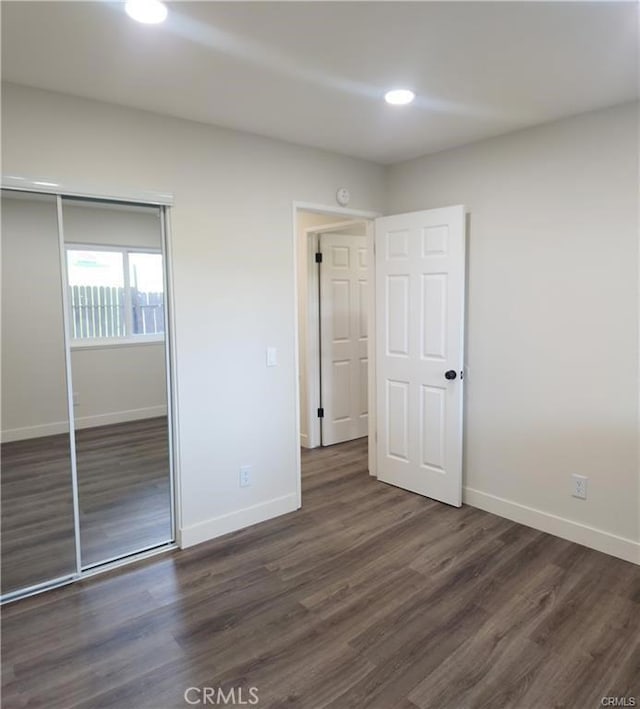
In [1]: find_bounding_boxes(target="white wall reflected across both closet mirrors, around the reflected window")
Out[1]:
[2,196,167,441]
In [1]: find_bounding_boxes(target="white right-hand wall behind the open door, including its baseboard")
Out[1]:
[388,105,640,562]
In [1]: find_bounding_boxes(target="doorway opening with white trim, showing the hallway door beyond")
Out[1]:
[294,206,377,502]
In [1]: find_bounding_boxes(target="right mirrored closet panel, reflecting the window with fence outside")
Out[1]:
[62,199,173,568]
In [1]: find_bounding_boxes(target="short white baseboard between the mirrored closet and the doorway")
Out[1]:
[177,493,298,549]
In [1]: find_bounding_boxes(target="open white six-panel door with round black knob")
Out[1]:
[375,206,465,507]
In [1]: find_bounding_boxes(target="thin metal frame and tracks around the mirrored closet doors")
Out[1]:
[0,176,180,604]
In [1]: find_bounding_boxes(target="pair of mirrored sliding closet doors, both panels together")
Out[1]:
[1,190,174,597]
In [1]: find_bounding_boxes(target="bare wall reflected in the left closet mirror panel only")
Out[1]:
[1,197,69,440]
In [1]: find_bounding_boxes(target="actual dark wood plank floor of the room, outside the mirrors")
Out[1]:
[2,441,640,709]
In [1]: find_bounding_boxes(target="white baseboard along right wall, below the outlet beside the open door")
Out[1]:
[462,487,640,564]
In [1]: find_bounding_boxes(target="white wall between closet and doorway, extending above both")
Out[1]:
[2,86,384,544]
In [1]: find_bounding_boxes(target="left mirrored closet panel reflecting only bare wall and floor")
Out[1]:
[0,190,76,594]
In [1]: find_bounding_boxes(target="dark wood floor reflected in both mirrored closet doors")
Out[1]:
[0,417,171,593]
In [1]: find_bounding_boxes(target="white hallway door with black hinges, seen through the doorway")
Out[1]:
[320,234,369,446]
